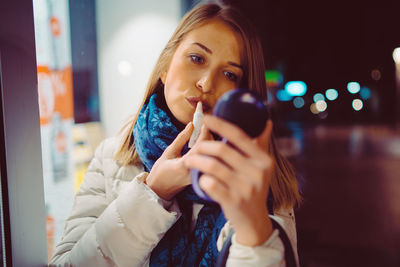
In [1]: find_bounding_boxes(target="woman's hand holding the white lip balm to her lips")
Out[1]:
[146,122,211,200]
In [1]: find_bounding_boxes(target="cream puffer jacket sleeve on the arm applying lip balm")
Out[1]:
[50,141,180,267]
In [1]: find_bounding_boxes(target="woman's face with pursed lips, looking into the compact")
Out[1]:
[161,20,243,124]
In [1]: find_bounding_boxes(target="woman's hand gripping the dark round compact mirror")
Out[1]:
[185,116,274,246]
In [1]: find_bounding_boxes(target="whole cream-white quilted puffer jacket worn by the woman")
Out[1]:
[50,138,297,267]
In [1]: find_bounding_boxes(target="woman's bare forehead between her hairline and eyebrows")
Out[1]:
[181,20,243,63]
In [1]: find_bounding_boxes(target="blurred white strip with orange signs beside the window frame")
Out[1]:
[33,0,74,257]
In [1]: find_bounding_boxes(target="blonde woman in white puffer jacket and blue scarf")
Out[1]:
[51,4,300,266]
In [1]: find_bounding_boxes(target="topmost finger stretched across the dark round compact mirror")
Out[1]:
[203,115,266,159]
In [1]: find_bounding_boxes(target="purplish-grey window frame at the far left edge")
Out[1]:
[0,0,47,266]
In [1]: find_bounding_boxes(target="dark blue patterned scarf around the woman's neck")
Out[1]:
[133,90,226,267]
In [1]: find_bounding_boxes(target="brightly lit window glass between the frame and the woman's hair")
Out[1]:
[33,0,181,264]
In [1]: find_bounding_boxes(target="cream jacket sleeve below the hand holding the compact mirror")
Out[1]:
[217,210,299,267]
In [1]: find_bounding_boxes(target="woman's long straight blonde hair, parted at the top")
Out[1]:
[115,4,301,210]
